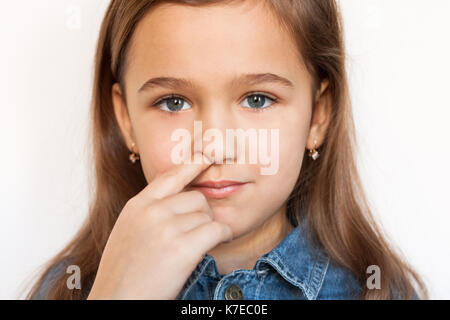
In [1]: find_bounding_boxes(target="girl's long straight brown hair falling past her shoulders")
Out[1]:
[27,0,428,299]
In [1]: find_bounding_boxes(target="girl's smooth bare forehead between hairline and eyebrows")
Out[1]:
[127,0,306,86]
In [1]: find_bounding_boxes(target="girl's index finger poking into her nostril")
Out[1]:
[142,155,212,199]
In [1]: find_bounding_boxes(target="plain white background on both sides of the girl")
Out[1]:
[0,0,450,299]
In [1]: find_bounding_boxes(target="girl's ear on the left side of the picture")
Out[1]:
[111,83,138,153]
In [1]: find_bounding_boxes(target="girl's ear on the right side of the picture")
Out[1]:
[306,80,332,149]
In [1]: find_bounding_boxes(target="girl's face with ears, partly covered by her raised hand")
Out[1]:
[113,1,329,237]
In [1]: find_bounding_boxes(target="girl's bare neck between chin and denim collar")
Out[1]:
[208,205,294,275]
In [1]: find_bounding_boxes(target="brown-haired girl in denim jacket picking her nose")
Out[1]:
[28,0,427,299]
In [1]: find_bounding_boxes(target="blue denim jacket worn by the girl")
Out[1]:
[176,223,361,300]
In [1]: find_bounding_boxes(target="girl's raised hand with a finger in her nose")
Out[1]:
[88,158,232,299]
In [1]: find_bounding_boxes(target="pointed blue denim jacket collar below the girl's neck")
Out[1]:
[182,221,330,300]
